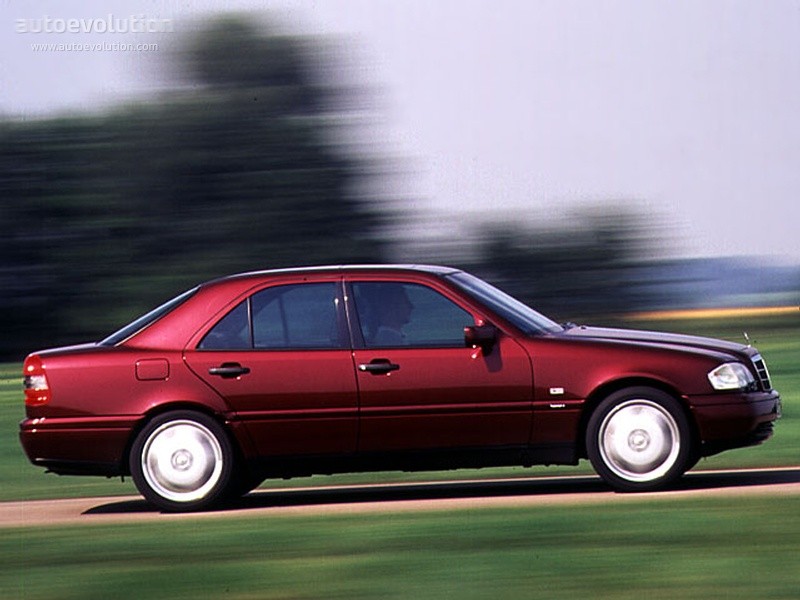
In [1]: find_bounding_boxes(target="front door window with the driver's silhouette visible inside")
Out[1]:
[352,282,475,348]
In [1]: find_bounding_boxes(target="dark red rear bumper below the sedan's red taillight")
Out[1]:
[19,417,137,475]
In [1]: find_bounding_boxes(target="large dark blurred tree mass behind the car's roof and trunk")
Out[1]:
[0,17,386,358]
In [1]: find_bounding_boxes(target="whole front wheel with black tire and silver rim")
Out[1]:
[586,387,696,492]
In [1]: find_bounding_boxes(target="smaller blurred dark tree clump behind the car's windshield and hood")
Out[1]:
[465,206,647,320]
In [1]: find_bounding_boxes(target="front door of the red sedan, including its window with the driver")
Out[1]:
[347,276,533,452]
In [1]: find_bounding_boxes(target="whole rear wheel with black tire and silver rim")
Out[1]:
[130,410,235,512]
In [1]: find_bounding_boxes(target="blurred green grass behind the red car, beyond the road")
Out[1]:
[0,311,800,500]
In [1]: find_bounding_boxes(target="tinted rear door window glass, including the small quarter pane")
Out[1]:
[198,282,347,350]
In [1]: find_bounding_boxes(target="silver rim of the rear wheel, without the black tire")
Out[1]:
[141,419,224,502]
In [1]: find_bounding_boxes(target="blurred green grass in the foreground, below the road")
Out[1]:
[0,496,800,600]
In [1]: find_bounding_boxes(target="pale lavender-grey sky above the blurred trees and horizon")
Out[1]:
[0,0,800,263]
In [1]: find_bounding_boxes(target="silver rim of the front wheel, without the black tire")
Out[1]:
[598,399,681,482]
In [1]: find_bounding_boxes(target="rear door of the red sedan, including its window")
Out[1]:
[185,277,358,456]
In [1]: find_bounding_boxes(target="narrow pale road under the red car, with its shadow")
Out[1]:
[0,467,800,527]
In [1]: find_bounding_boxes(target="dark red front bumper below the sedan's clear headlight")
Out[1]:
[690,390,781,456]
